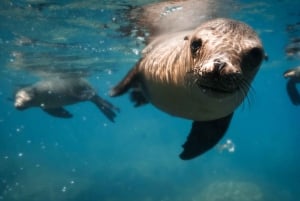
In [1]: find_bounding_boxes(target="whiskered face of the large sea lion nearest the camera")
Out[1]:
[188,19,264,96]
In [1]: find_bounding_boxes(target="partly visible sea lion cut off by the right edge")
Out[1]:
[283,66,300,105]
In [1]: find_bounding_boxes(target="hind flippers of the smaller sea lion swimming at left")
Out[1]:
[91,95,119,122]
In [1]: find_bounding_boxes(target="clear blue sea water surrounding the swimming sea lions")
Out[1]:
[0,0,300,201]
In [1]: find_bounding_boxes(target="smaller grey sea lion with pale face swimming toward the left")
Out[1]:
[14,77,118,121]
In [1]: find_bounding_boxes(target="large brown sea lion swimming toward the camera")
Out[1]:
[110,18,265,160]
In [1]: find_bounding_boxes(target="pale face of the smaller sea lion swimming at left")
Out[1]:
[14,89,33,110]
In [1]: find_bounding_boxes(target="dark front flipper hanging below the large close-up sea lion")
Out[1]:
[180,113,233,160]
